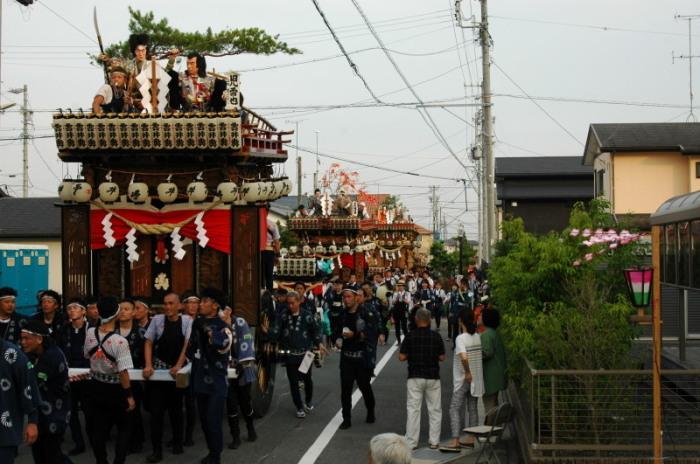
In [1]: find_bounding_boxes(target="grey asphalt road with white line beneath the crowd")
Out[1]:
[17,324,474,464]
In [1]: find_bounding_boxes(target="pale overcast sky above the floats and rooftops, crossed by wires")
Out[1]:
[0,0,700,239]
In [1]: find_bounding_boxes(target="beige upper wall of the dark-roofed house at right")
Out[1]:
[611,152,695,214]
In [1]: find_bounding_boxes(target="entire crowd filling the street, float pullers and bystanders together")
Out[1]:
[0,262,505,464]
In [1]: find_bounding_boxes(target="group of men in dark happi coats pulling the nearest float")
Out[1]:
[0,287,257,464]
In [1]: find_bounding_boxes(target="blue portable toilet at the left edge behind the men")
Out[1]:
[0,243,49,315]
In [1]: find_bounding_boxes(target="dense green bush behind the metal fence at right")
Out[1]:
[489,201,643,377]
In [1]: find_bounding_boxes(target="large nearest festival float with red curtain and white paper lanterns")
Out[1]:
[53,51,292,414]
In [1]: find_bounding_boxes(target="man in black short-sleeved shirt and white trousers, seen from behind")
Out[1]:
[399,308,445,449]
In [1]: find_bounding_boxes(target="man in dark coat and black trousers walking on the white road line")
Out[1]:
[332,287,378,430]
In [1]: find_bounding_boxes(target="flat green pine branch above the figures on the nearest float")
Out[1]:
[105,7,301,58]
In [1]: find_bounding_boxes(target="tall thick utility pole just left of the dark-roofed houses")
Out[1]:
[479,0,496,261]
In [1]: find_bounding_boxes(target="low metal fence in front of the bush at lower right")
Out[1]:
[525,365,700,462]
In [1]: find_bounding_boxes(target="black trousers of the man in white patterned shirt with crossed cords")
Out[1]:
[87,380,130,464]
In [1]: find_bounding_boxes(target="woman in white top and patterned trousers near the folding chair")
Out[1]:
[440,309,484,453]
